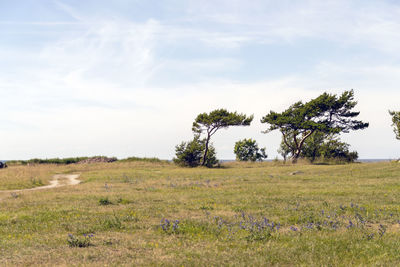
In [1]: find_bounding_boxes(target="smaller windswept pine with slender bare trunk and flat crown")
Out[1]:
[192,109,253,166]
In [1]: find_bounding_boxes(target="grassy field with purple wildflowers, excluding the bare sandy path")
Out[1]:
[0,162,400,266]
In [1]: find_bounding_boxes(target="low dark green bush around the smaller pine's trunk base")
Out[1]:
[174,135,218,167]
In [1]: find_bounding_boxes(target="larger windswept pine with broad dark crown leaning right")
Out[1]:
[261,90,369,163]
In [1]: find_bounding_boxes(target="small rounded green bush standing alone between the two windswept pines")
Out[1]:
[234,138,268,161]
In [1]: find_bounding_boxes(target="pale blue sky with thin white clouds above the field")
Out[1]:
[0,0,400,159]
